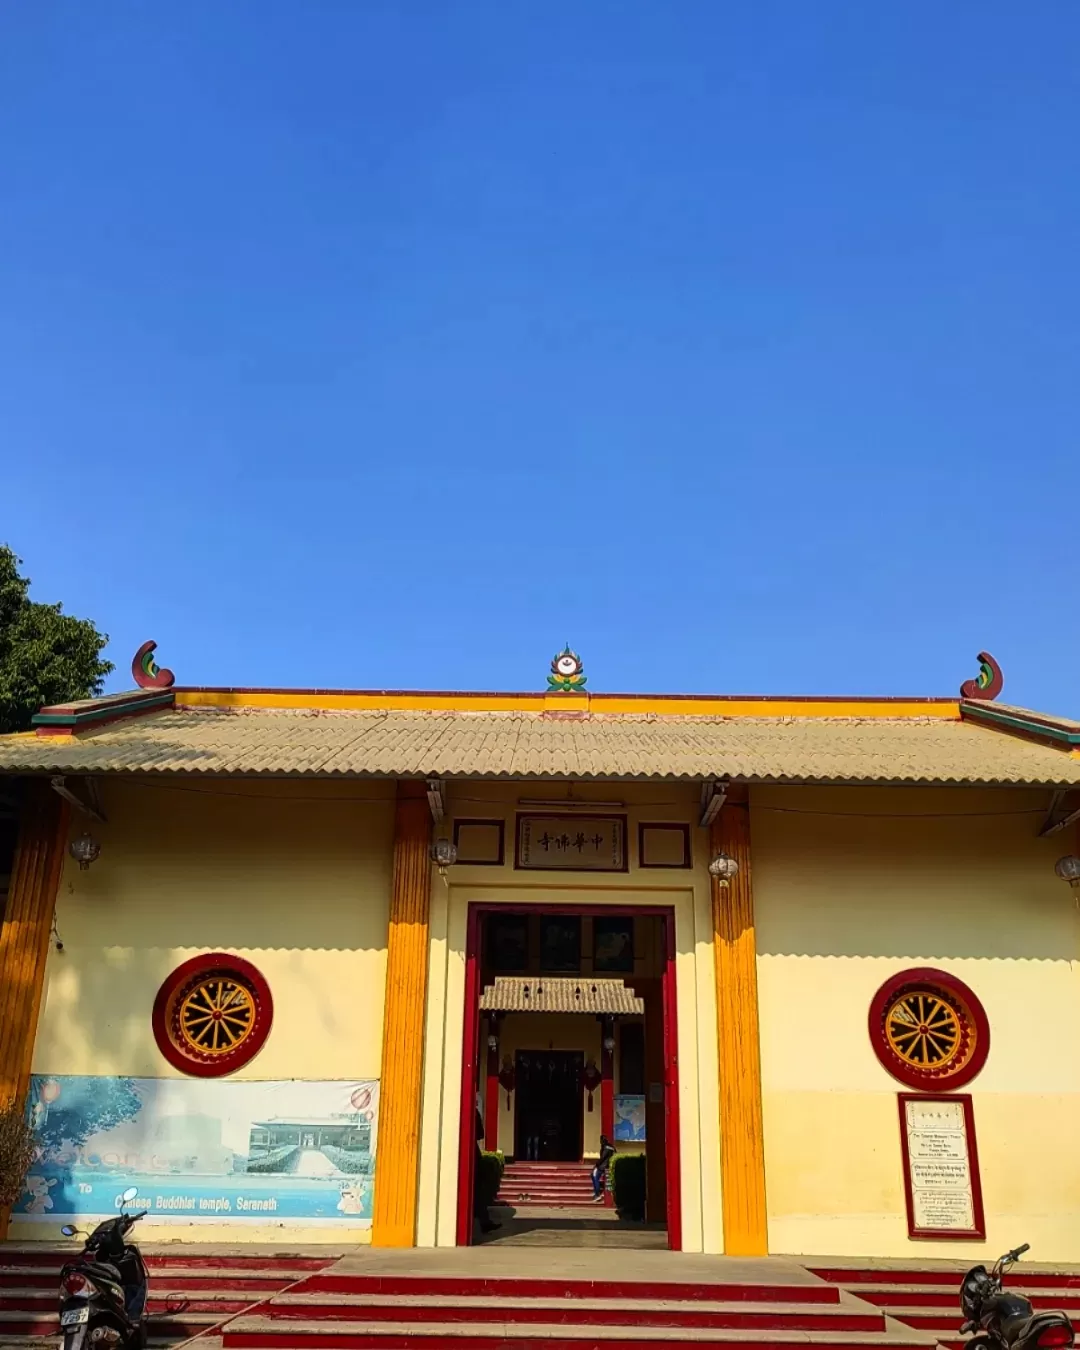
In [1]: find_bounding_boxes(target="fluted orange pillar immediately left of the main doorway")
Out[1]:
[371,783,431,1247]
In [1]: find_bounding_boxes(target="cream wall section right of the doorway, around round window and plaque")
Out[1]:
[751,787,1080,1262]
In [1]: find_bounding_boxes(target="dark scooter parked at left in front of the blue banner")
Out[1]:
[59,1187,150,1350]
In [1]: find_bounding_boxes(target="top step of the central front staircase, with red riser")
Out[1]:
[302,1270,841,1305]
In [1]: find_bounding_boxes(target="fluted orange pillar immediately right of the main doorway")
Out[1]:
[710,795,768,1257]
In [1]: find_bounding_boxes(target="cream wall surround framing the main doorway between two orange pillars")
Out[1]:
[417,783,724,1253]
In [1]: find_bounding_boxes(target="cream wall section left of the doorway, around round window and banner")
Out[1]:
[16,779,394,1242]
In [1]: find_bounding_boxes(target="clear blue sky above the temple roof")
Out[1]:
[0,0,1080,716]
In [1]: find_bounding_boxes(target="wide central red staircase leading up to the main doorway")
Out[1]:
[223,1269,934,1350]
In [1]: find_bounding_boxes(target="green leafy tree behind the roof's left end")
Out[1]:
[0,544,112,733]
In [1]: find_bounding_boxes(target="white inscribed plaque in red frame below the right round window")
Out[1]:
[898,1092,987,1238]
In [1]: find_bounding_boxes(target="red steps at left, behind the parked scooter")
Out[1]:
[0,1246,339,1346]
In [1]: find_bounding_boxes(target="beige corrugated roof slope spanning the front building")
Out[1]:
[0,709,1080,787]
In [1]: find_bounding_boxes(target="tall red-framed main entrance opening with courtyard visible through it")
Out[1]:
[458,903,682,1250]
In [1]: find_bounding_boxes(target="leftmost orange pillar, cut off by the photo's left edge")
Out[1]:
[0,780,68,1241]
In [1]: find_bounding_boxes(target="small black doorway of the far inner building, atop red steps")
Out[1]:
[514,1050,585,1162]
